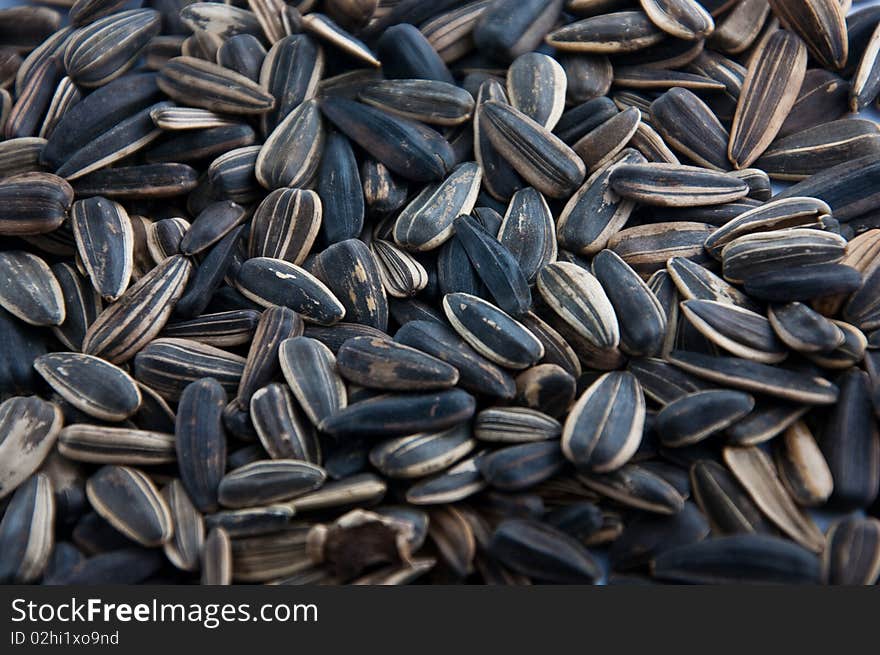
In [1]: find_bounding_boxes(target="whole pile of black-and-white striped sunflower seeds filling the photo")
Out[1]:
[0,0,880,584]
